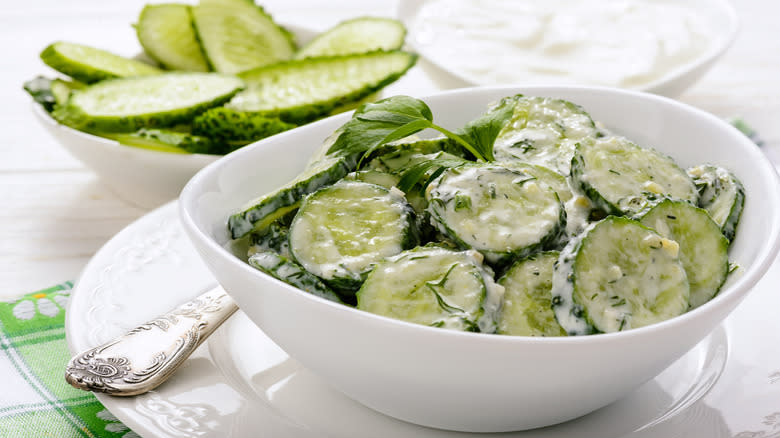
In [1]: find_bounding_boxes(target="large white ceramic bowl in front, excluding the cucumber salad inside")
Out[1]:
[180,87,780,432]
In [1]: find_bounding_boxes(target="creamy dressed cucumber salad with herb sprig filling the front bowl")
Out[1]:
[227,95,745,336]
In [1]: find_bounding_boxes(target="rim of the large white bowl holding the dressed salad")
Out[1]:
[179,85,780,345]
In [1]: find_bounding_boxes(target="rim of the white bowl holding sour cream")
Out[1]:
[396,0,740,94]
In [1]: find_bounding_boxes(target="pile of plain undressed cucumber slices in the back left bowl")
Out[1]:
[24,0,417,155]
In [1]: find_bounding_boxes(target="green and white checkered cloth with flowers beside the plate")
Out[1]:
[0,282,140,438]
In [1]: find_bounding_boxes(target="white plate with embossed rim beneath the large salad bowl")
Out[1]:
[66,203,780,438]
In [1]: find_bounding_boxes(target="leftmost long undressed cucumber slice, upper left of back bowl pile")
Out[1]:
[41,41,162,84]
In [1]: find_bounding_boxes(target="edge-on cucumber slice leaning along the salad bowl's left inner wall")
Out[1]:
[228,157,349,239]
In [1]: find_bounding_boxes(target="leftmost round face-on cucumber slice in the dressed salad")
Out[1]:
[289,180,418,292]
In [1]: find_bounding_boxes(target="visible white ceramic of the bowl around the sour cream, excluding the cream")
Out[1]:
[397,0,739,97]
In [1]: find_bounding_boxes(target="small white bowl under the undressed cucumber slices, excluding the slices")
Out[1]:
[32,25,315,208]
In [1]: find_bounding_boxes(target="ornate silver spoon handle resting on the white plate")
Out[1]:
[65,286,238,396]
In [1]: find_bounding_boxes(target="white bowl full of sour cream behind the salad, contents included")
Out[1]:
[398,0,738,97]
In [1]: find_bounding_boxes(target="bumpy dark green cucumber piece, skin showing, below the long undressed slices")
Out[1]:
[192,107,296,143]
